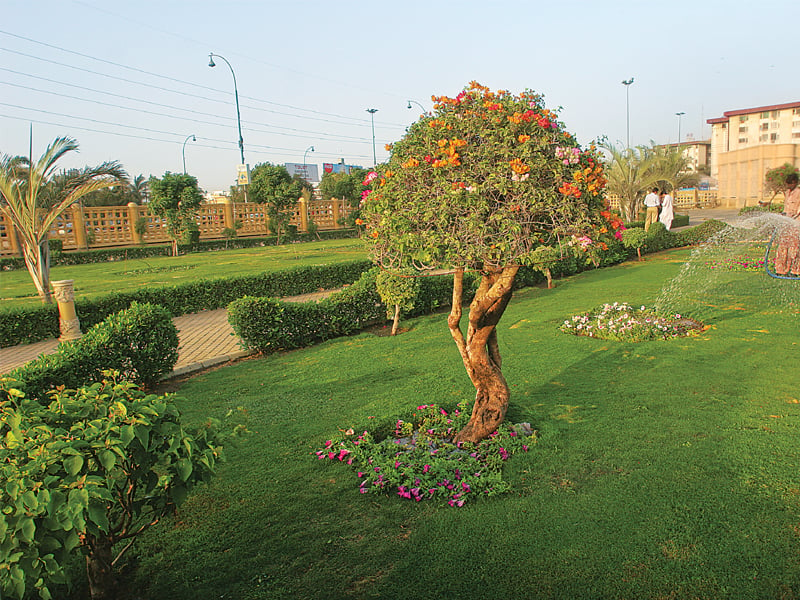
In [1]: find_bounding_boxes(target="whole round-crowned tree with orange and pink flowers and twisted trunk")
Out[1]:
[362,82,608,442]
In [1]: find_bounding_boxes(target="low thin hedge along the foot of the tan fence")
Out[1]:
[0,229,358,271]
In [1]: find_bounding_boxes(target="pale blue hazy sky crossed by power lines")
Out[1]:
[0,0,800,191]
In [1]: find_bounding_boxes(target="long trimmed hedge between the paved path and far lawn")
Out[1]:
[0,260,372,348]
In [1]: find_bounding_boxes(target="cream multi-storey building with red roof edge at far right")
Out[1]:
[707,102,800,207]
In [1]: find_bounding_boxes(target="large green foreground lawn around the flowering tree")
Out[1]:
[92,250,800,600]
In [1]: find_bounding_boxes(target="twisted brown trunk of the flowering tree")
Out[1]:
[447,267,519,442]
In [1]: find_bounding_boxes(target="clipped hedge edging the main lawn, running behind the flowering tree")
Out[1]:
[223,220,726,353]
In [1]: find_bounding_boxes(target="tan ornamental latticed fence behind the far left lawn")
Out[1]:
[0,199,351,256]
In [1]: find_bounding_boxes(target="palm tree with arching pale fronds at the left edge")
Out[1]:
[0,137,127,304]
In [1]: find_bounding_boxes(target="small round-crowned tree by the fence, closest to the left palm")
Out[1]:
[147,171,203,256]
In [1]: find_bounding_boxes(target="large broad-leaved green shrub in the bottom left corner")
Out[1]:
[0,373,238,599]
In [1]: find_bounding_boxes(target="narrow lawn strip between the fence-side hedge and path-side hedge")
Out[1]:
[0,239,366,308]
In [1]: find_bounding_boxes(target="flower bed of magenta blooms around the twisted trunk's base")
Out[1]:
[316,402,536,507]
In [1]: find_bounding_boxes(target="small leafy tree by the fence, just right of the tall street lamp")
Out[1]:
[248,163,311,244]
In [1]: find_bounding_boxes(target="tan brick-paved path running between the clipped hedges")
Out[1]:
[0,208,752,376]
